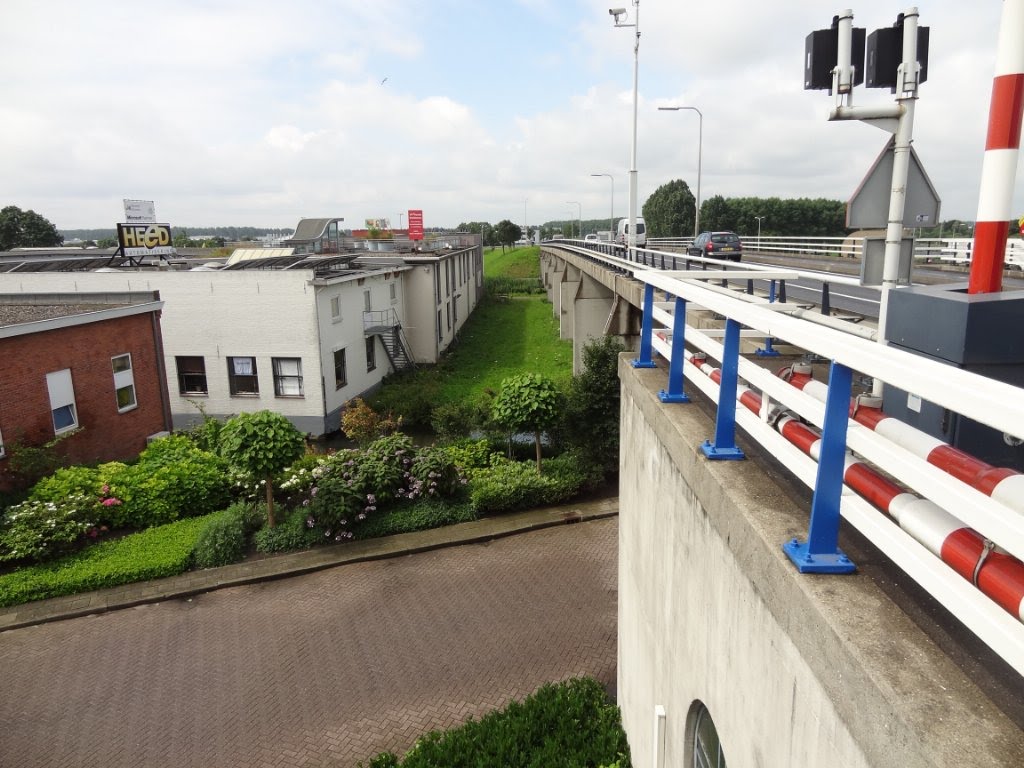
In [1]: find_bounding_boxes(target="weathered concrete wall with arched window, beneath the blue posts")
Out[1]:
[618,353,1024,768]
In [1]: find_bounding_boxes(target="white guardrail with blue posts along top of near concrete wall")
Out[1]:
[536,242,1024,674]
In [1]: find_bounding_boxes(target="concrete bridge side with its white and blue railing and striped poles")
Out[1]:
[542,242,1024,766]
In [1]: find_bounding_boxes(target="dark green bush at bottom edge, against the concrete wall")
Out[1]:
[360,678,631,768]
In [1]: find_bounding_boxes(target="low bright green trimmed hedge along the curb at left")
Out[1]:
[0,517,206,606]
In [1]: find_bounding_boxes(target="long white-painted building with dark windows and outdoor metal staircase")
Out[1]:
[0,225,483,436]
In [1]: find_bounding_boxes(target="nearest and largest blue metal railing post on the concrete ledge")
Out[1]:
[782,361,856,573]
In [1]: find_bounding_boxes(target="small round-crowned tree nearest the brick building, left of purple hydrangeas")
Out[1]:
[220,411,305,528]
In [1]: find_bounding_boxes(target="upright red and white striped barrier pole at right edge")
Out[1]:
[968,0,1024,294]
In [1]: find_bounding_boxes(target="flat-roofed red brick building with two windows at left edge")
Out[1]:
[0,291,171,488]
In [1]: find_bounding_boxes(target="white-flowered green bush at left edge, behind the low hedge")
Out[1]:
[0,494,99,562]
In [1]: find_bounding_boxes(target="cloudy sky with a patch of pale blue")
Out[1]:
[0,0,1024,234]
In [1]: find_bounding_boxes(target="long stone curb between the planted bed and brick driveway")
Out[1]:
[0,498,618,632]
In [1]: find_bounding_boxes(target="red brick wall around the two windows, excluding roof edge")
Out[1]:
[0,312,170,487]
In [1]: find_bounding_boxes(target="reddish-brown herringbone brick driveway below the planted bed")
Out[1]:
[0,518,617,768]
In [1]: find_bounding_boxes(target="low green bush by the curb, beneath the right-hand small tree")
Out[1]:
[469,459,582,515]
